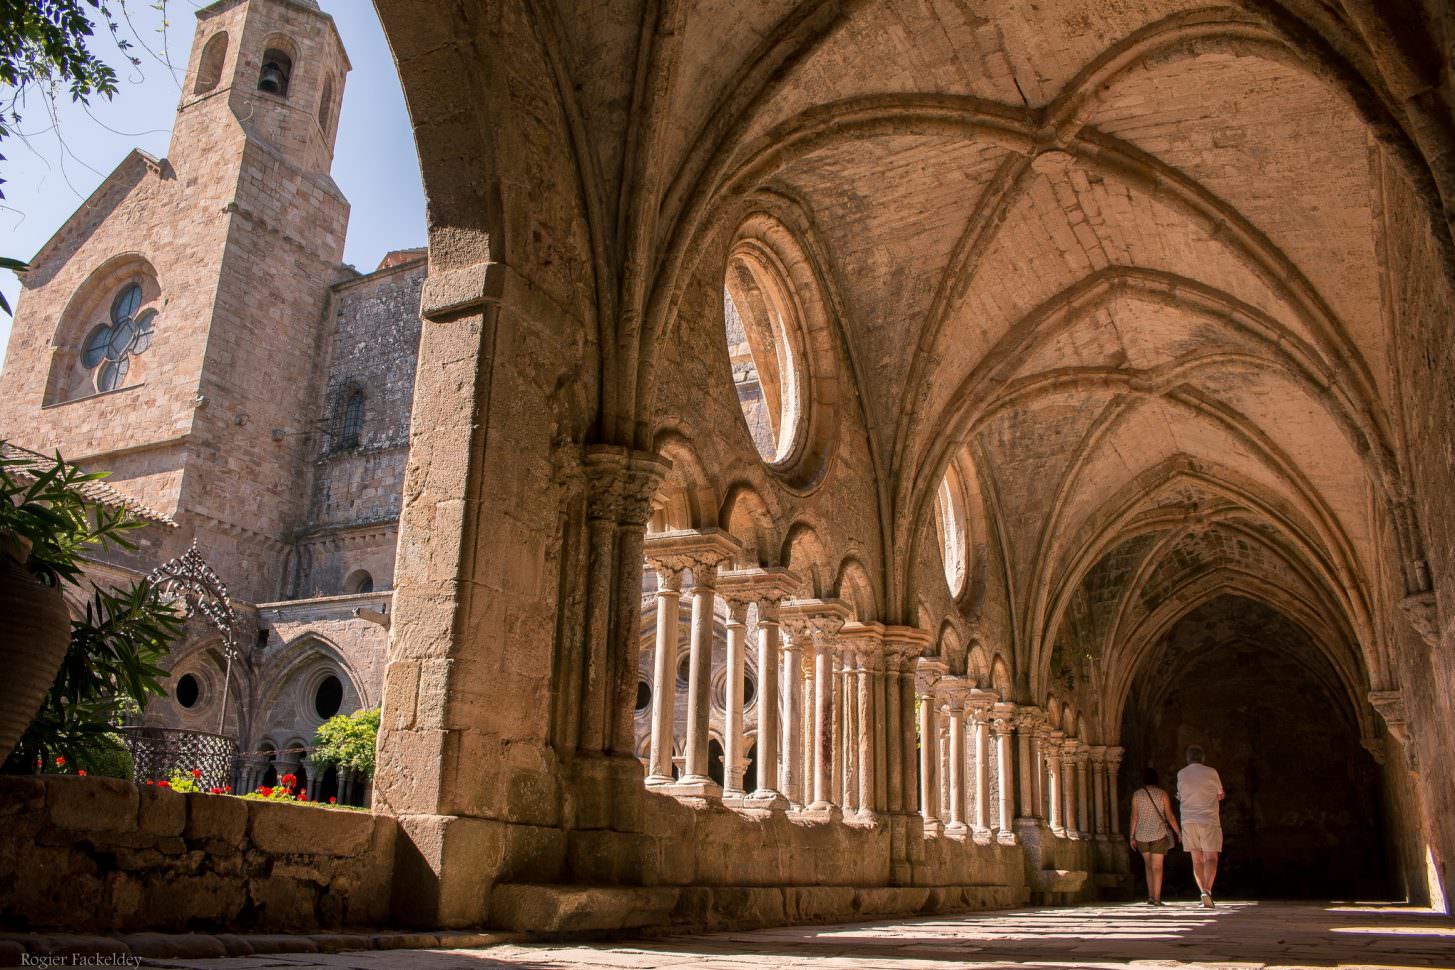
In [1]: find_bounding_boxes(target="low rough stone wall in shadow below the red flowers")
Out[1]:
[0,777,397,932]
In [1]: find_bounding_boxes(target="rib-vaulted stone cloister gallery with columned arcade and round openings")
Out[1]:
[8,0,1455,948]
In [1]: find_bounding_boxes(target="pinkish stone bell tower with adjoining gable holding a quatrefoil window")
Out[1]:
[0,0,349,602]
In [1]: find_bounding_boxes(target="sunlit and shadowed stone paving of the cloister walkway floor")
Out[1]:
[143,902,1455,970]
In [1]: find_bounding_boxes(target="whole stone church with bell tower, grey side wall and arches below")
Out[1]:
[0,0,425,801]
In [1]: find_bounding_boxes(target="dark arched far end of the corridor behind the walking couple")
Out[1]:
[1120,596,1392,899]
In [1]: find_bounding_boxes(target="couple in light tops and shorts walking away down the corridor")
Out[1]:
[1128,745,1222,909]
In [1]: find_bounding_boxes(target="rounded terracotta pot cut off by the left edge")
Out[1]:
[0,556,71,761]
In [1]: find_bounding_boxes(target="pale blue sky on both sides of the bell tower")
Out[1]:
[0,0,425,369]
